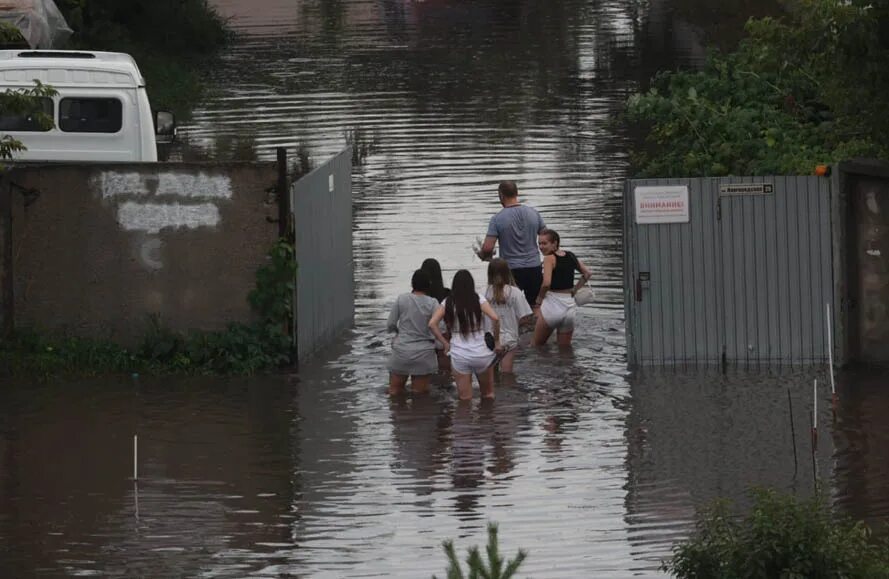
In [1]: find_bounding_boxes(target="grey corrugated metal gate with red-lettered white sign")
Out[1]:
[624,176,835,366]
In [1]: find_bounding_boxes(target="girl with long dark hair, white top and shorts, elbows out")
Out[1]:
[429,269,501,400]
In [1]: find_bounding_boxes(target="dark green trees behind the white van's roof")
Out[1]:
[56,0,231,117]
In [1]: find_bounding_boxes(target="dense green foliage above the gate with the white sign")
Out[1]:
[627,0,889,177]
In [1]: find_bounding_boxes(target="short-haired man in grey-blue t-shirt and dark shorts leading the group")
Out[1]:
[478,181,546,307]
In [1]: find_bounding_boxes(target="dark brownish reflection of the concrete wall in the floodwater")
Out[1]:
[0,379,299,577]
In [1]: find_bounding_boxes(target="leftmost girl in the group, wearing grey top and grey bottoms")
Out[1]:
[386,269,438,396]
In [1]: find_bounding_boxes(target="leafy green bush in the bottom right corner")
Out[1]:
[664,490,889,579]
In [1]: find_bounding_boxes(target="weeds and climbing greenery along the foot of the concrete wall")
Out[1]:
[0,239,297,376]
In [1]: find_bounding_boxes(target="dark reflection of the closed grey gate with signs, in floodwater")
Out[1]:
[626,369,835,563]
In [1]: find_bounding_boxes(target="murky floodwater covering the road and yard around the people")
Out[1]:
[0,0,889,578]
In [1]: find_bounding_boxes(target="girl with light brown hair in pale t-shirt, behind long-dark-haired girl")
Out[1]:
[485,258,533,373]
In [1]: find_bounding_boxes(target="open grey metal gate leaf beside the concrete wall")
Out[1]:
[290,148,355,362]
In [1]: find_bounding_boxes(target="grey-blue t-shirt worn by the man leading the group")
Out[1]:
[488,205,546,269]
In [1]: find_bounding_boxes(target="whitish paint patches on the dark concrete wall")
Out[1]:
[93,171,232,270]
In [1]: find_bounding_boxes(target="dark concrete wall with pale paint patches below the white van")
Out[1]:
[3,163,278,343]
